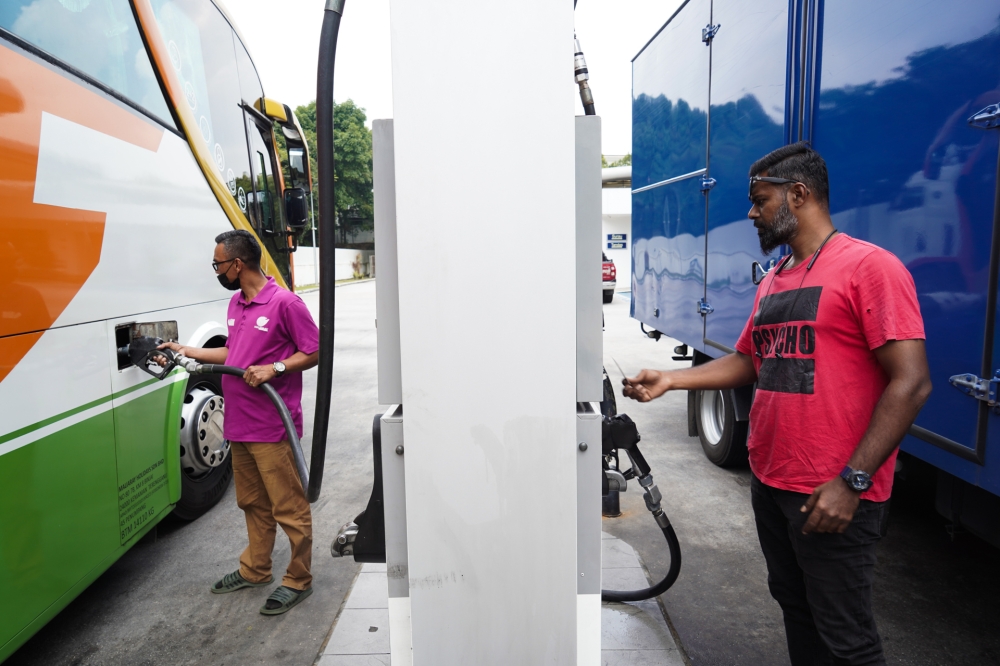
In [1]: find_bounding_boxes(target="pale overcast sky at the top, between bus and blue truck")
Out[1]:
[224,0,682,155]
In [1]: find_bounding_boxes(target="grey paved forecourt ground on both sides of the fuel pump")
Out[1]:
[7,283,1000,666]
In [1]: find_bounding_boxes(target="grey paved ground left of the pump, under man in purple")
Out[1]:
[5,282,378,666]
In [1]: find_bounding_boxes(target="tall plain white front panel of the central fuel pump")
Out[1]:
[390,0,579,666]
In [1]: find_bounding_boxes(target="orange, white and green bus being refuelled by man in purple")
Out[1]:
[0,0,312,662]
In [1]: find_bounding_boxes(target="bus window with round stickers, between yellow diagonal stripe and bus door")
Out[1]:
[152,0,253,220]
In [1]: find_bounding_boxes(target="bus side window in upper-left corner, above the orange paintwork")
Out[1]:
[0,0,174,128]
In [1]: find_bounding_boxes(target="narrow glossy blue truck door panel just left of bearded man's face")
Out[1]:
[704,0,798,356]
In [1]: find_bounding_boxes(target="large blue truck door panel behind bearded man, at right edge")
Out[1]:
[814,0,1000,493]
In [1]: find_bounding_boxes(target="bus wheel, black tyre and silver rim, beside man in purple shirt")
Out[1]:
[173,376,233,520]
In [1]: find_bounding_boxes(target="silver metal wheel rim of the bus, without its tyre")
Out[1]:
[181,386,229,477]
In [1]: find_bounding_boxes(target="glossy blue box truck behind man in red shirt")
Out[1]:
[631,0,1000,545]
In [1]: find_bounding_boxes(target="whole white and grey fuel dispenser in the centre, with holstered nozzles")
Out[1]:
[317,0,680,666]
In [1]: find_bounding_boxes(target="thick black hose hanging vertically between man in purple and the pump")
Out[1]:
[306,0,344,502]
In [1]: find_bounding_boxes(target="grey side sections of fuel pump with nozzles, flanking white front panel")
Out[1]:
[330,122,681,664]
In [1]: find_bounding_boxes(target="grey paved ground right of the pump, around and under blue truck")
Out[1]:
[604,296,1000,666]
